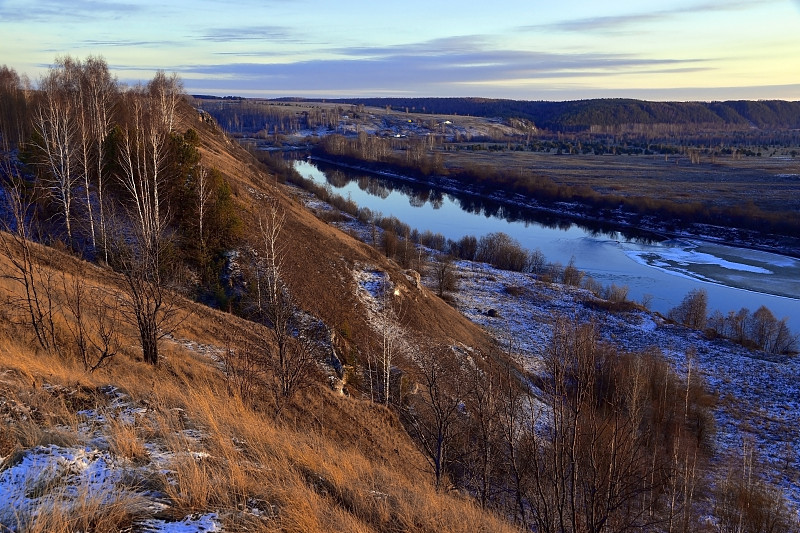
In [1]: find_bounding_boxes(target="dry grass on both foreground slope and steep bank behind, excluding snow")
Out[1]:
[0,103,510,533]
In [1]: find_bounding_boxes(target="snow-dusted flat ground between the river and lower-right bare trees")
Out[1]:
[446,262,800,509]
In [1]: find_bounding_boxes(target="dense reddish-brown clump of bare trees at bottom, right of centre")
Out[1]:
[526,320,668,533]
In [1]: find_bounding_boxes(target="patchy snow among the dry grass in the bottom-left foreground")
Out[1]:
[0,380,221,533]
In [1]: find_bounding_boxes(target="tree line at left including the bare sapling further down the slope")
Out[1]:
[0,57,346,416]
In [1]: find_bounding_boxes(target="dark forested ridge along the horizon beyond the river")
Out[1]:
[270,98,800,133]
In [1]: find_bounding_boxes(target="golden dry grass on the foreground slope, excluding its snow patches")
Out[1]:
[0,239,512,532]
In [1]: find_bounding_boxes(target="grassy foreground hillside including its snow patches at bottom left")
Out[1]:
[0,243,516,531]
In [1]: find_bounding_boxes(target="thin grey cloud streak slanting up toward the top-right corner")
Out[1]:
[519,0,782,33]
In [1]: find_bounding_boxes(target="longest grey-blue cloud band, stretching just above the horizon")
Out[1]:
[170,44,705,95]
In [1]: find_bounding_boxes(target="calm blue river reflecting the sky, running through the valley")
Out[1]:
[294,160,800,333]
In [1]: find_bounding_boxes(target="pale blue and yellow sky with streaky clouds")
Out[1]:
[0,0,800,101]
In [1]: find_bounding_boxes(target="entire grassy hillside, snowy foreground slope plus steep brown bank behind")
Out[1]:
[0,97,508,531]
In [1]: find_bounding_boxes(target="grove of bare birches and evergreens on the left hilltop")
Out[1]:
[0,57,247,366]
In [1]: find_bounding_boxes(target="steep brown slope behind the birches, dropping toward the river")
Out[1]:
[185,104,500,360]
